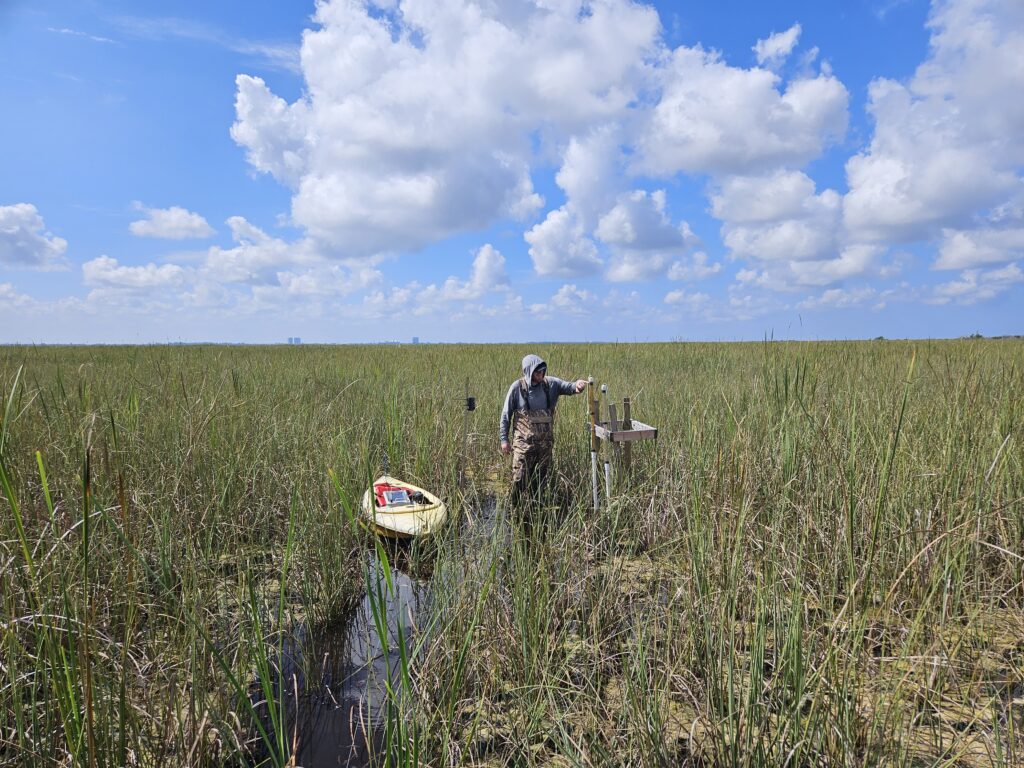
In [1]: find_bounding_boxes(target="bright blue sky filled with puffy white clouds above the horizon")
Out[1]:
[0,0,1024,343]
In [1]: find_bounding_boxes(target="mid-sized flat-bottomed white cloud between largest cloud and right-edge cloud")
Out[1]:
[637,47,849,176]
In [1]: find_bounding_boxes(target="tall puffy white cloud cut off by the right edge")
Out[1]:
[844,0,1024,242]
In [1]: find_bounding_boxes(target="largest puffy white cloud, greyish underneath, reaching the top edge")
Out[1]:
[232,0,658,256]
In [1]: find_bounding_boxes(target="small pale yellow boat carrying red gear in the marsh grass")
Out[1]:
[360,475,447,539]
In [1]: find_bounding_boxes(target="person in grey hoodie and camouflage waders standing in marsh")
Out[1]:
[500,354,587,501]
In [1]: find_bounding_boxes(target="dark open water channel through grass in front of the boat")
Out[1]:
[260,551,431,768]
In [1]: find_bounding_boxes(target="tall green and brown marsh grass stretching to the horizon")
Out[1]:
[0,340,1024,766]
